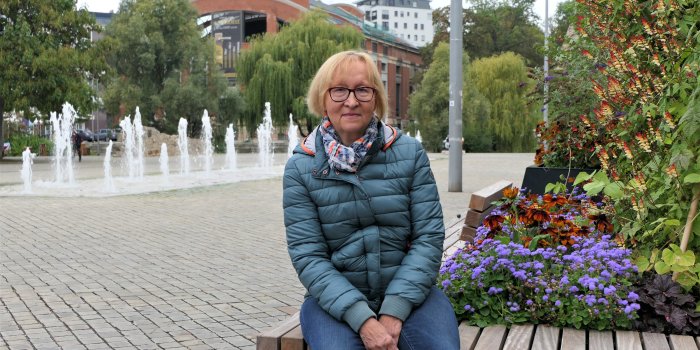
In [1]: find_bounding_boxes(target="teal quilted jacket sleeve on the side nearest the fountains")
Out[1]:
[283,157,376,332]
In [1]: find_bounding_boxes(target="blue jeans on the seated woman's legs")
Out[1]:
[300,286,459,350]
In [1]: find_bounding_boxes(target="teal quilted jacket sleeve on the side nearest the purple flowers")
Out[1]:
[379,142,445,321]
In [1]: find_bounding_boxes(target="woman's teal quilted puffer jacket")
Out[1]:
[283,123,445,332]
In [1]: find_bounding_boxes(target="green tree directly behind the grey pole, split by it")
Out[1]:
[408,42,491,151]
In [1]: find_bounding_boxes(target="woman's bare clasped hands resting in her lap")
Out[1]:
[360,315,403,350]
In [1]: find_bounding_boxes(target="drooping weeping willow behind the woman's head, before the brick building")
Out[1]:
[236,11,363,134]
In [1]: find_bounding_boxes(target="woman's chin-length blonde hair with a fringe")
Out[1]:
[306,51,389,119]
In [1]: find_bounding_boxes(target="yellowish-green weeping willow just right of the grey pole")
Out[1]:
[469,52,538,152]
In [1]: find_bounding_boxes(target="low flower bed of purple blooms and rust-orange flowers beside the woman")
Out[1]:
[439,189,639,330]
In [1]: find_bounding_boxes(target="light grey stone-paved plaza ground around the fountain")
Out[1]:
[0,153,533,349]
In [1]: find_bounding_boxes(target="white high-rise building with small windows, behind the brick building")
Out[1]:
[357,0,435,47]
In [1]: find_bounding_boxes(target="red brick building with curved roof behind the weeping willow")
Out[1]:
[192,0,422,128]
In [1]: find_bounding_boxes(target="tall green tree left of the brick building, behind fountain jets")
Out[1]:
[104,0,227,136]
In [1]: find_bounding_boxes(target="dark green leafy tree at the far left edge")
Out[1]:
[0,0,107,158]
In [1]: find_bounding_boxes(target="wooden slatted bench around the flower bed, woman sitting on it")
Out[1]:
[257,181,700,350]
